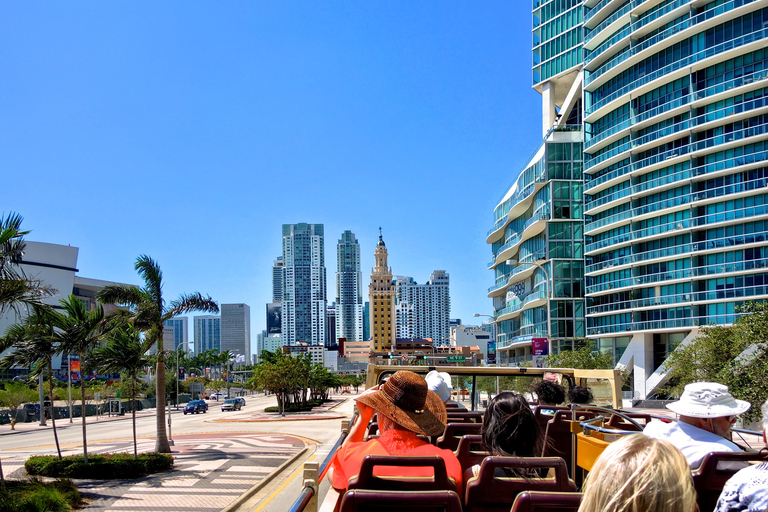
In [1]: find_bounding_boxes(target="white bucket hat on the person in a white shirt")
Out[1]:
[667,382,752,418]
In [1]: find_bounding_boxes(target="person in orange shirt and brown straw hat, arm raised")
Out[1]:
[331,371,462,491]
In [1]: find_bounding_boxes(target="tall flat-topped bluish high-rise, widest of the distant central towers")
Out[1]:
[282,223,327,346]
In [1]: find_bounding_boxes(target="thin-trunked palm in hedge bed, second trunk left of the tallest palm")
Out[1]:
[54,295,117,464]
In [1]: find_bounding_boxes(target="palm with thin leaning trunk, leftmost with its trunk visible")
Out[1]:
[0,306,62,459]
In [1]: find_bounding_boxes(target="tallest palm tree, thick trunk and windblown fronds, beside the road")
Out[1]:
[97,255,219,453]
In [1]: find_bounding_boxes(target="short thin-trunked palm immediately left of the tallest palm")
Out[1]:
[91,324,149,459]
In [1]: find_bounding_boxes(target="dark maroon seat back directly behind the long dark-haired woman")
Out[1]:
[464,456,576,512]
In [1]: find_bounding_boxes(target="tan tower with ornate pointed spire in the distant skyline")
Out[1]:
[368,228,396,351]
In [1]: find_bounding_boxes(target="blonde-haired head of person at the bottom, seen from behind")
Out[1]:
[579,434,696,512]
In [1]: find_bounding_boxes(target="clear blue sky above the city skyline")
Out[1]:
[0,0,541,352]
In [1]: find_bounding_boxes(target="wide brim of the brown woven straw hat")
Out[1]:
[357,390,448,436]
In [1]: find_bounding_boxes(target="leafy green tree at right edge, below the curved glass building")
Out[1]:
[664,302,768,421]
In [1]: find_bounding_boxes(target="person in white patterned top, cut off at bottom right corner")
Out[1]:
[715,401,768,512]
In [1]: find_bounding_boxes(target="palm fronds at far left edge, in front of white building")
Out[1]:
[0,213,53,314]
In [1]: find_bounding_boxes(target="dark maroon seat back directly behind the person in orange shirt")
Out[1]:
[348,455,456,491]
